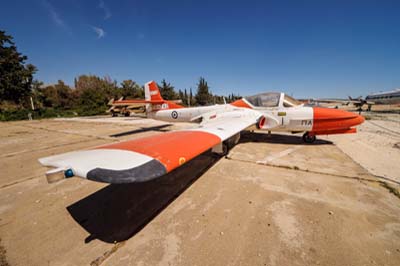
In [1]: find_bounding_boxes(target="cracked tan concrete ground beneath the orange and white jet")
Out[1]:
[0,117,400,265]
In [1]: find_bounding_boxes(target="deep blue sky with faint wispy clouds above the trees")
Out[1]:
[0,0,400,97]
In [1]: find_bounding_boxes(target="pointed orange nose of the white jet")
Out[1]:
[312,107,365,132]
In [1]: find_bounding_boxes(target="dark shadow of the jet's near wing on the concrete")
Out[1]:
[67,151,221,243]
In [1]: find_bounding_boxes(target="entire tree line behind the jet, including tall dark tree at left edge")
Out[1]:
[0,31,239,120]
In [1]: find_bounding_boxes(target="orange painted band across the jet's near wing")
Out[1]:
[98,131,221,172]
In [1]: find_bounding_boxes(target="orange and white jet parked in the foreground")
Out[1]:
[39,81,364,183]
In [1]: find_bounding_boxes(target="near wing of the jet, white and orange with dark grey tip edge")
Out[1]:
[39,109,261,183]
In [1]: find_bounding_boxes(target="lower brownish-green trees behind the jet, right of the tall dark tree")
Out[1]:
[31,75,240,109]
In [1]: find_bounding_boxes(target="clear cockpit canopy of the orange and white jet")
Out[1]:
[245,92,302,108]
